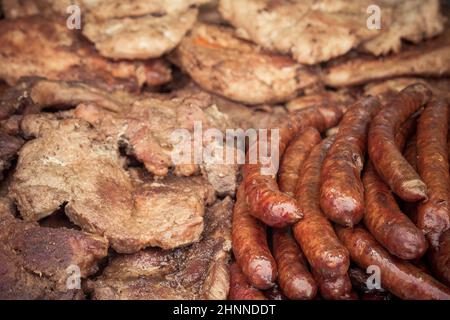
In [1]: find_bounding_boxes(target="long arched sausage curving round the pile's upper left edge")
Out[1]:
[242,106,343,228]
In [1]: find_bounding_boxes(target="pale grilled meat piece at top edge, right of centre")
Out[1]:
[220,0,382,64]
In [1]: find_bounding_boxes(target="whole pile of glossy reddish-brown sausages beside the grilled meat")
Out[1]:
[229,84,450,299]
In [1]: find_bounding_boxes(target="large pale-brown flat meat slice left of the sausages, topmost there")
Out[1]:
[10,114,214,253]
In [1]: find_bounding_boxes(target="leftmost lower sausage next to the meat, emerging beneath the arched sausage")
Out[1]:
[232,187,277,290]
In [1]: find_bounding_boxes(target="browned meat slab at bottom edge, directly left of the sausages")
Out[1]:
[88,197,233,300]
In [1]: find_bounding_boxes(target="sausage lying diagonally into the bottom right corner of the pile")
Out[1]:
[336,226,450,300]
